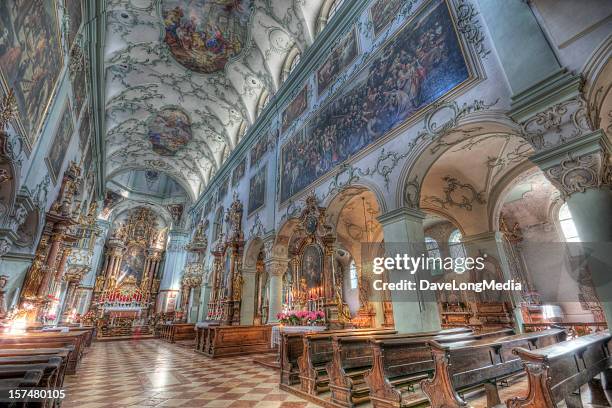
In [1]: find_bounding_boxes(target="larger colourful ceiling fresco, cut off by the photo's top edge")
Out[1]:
[162,0,253,74]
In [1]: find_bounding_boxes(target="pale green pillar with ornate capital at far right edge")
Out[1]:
[530,129,612,324]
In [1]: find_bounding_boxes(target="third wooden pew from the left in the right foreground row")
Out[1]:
[327,327,477,407]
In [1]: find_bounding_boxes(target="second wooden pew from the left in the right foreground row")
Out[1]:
[298,329,397,395]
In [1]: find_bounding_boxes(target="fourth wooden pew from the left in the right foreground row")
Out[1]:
[364,329,514,408]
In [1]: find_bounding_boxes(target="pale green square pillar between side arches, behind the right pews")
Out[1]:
[374,207,441,333]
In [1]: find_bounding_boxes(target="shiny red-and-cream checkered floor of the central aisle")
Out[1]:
[62,340,317,408]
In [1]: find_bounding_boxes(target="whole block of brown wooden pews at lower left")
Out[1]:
[0,327,94,407]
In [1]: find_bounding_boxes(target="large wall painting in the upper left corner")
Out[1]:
[0,0,64,147]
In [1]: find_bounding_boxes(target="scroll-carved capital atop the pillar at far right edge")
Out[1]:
[530,129,612,199]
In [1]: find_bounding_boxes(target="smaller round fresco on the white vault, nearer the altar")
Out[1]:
[149,108,192,156]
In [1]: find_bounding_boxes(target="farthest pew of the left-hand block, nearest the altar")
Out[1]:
[0,331,86,374]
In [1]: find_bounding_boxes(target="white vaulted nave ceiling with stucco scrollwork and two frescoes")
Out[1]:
[104,0,324,196]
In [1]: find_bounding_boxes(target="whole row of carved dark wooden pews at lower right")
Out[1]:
[279,327,612,408]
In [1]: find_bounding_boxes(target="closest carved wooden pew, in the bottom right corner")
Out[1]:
[506,331,612,408]
